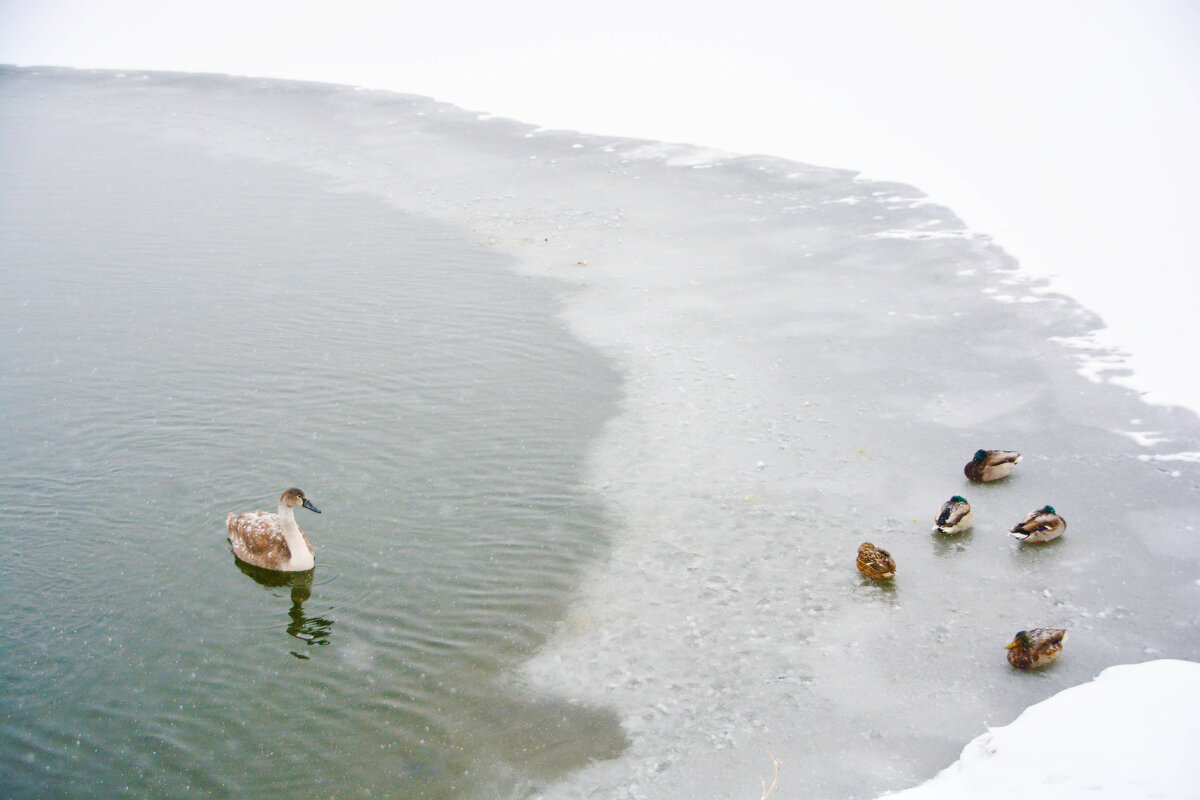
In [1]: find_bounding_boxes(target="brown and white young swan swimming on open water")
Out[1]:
[226,489,320,572]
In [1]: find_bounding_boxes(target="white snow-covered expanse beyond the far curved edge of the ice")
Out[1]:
[0,0,1200,409]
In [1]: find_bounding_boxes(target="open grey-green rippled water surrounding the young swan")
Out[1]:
[0,80,625,798]
